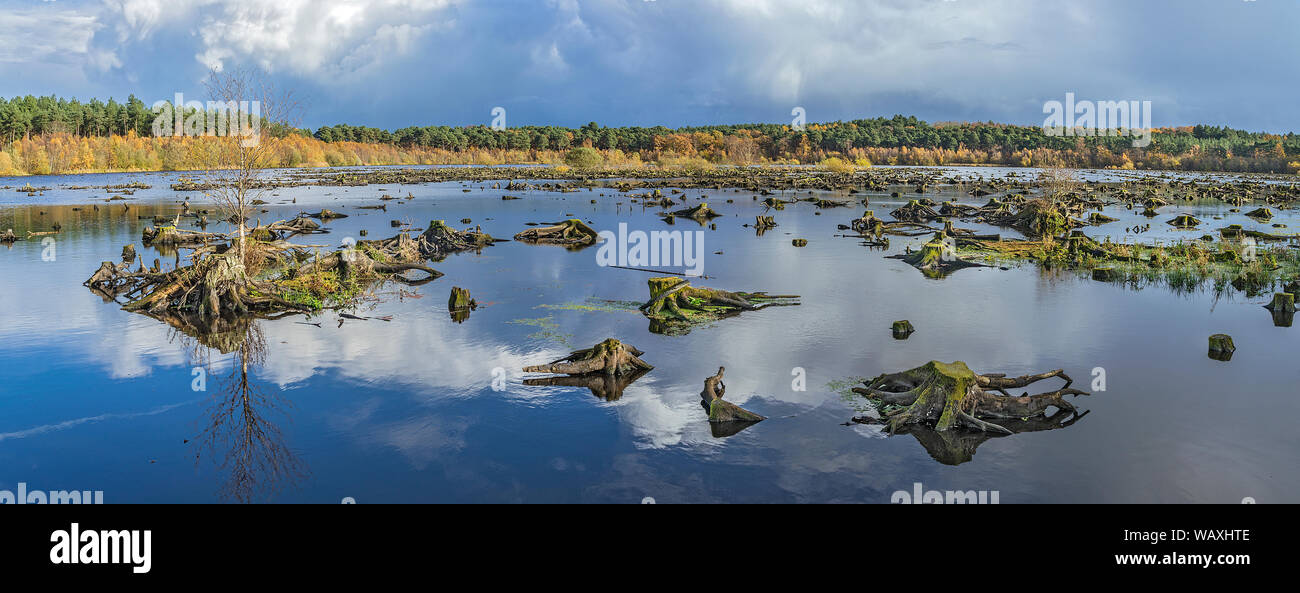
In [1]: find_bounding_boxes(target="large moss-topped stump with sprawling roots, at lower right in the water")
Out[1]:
[853,360,1088,434]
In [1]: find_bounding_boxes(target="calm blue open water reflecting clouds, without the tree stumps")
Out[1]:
[0,169,1300,503]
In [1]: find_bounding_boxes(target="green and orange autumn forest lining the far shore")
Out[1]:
[0,96,1300,174]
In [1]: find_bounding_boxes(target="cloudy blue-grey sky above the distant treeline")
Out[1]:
[0,0,1300,131]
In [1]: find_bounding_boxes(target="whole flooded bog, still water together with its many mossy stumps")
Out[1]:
[0,166,1300,503]
